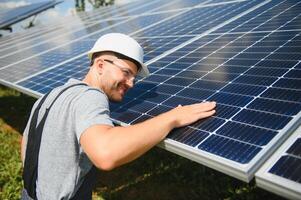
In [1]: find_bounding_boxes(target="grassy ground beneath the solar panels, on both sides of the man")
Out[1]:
[0,86,282,200]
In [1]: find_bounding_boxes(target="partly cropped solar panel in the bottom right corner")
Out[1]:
[256,128,301,199]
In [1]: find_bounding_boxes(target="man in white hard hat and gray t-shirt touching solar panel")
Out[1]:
[22,33,215,199]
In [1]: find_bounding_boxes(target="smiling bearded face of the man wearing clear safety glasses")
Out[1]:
[100,56,137,102]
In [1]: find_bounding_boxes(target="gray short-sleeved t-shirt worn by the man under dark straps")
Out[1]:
[23,79,113,199]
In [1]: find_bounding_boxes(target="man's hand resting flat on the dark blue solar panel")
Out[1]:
[166,102,216,128]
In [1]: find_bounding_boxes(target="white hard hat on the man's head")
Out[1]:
[88,33,149,77]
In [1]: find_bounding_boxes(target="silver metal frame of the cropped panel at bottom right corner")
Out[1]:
[255,124,301,199]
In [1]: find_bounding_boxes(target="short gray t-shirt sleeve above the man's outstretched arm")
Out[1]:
[75,89,113,140]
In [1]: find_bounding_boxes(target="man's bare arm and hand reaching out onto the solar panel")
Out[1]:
[80,102,216,170]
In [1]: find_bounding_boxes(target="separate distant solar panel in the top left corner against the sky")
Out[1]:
[0,1,61,28]
